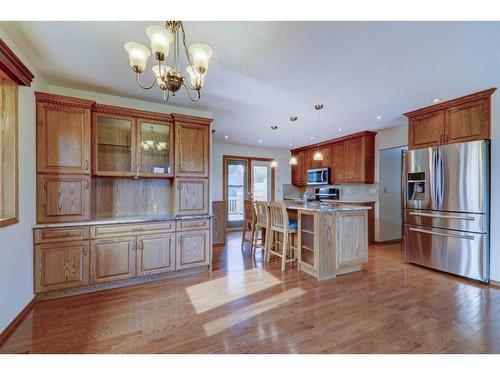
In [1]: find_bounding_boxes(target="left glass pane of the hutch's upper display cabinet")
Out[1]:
[97,116,132,172]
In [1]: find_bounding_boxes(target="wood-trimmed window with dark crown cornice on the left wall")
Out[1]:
[0,39,35,227]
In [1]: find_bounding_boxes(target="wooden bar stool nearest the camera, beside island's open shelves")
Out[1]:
[266,202,298,271]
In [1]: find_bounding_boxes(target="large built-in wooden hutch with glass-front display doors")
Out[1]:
[34,92,212,298]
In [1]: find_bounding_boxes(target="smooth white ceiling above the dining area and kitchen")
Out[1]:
[2,21,500,148]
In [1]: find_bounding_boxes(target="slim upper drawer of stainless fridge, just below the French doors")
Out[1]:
[405,210,488,233]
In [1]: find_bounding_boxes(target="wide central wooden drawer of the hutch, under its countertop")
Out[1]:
[90,221,175,238]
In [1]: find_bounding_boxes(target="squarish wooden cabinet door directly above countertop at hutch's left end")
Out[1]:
[37,174,90,223]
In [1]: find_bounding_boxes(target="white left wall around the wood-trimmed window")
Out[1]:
[0,27,48,332]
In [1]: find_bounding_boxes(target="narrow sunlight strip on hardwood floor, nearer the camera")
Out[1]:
[203,288,305,336]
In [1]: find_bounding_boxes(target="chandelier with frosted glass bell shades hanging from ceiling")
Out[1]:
[124,21,213,102]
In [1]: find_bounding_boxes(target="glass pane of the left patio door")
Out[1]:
[227,160,247,227]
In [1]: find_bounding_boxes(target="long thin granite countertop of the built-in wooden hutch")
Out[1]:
[33,215,213,229]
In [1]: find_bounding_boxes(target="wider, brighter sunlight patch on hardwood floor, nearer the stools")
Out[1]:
[186,268,282,314]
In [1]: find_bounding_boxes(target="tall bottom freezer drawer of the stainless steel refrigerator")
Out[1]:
[405,225,489,282]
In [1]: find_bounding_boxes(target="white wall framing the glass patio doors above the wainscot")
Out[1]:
[211,142,291,201]
